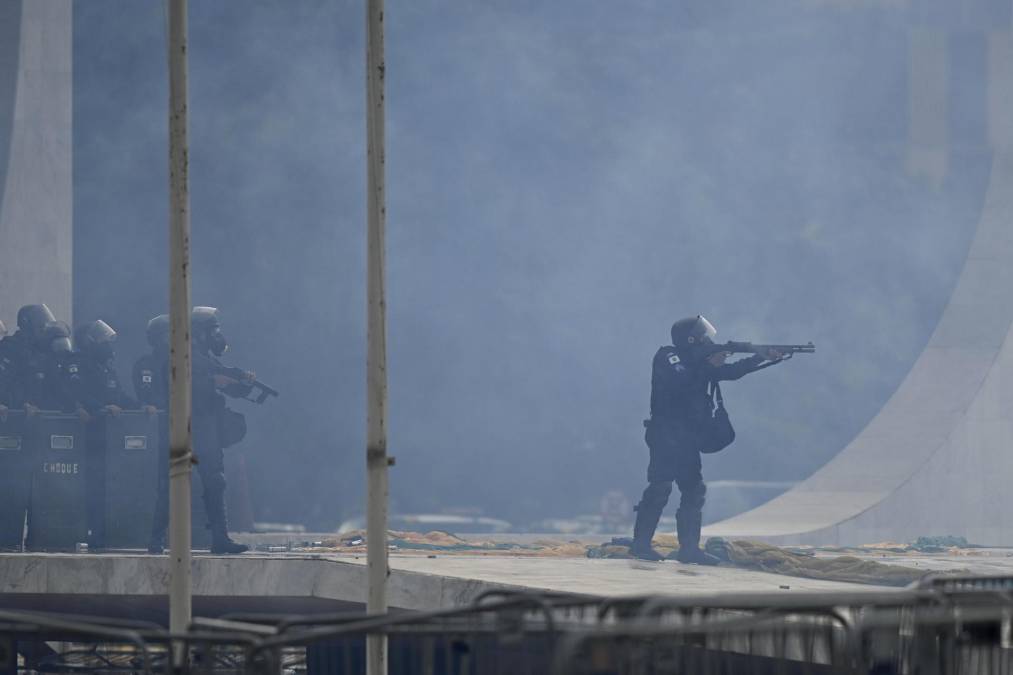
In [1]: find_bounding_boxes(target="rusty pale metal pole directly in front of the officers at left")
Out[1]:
[168,0,192,632]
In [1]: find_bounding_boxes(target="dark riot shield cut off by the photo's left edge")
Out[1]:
[0,411,31,549]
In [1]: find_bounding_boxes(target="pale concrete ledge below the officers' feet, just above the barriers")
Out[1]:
[0,553,883,623]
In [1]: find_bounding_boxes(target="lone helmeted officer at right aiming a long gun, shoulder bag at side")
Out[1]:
[630,316,782,565]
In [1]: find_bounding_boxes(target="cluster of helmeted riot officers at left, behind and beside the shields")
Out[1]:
[0,304,256,553]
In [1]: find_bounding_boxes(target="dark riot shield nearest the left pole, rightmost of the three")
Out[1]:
[100,411,161,548]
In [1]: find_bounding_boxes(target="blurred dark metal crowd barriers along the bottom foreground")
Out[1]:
[0,577,1013,675]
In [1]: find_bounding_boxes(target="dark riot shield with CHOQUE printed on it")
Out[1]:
[26,413,88,550]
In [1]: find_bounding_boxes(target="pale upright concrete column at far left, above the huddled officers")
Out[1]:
[0,0,73,328]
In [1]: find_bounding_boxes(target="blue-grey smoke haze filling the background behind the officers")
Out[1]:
[74,0,989,529]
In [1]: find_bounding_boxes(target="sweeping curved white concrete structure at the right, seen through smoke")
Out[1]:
[706,27,1013,545]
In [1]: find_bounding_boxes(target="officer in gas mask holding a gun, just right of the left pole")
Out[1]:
[190,307,254,553]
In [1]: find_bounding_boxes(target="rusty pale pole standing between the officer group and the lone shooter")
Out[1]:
[366,0,390,675]
